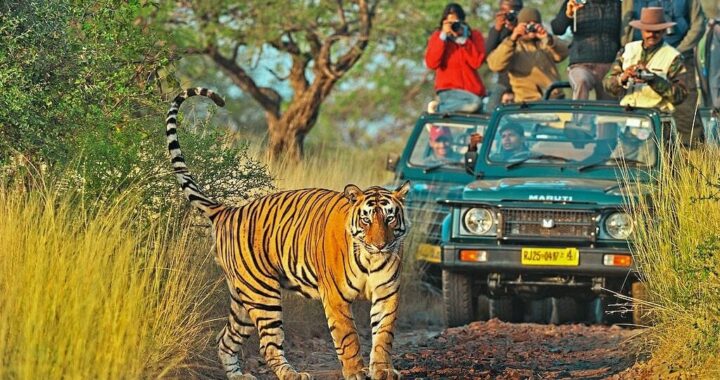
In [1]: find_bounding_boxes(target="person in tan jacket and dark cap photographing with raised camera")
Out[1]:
[488,8,568,102]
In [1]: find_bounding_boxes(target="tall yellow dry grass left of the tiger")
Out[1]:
[0,180,214,379]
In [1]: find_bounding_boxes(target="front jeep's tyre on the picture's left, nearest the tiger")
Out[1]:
[442,269,476,327]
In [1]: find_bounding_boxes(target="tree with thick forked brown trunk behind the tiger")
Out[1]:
[170,0,394,160]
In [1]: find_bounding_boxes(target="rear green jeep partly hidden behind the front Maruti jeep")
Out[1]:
[387,113,489,288]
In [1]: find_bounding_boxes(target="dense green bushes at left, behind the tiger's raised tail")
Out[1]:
[0,0,271,211]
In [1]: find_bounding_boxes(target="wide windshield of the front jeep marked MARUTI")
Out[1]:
[486,111,657,171]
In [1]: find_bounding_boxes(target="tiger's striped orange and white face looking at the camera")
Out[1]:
[345,182,410,254]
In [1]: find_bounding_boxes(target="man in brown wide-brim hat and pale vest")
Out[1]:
[603,7,688,112]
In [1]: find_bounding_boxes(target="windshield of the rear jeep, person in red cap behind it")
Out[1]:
[409,122,486,171]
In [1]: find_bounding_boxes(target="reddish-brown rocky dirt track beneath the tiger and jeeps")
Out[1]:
[201,320,638,379]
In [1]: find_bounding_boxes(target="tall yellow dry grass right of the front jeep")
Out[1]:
[630,148,720,378]
